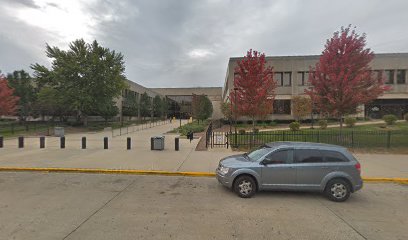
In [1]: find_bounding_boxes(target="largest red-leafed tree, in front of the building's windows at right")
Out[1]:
[305,25,389,128]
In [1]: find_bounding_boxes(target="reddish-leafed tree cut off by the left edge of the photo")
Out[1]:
[0,75,19,116]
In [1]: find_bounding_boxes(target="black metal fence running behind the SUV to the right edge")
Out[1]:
[228,130,408,148]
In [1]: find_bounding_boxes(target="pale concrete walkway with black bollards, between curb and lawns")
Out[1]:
[0,121,408,178]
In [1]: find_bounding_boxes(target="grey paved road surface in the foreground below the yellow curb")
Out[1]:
[0,172,408,239]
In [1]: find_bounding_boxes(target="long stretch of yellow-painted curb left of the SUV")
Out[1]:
[0,167,215,177]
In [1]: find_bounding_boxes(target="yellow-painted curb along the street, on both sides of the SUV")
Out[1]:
[0,167,408,184]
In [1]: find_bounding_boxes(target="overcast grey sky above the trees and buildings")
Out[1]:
[0,0,408,87]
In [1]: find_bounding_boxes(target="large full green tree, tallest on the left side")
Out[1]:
[31,39,126,125]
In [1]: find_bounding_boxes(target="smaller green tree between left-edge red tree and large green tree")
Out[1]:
[7,70,36,121]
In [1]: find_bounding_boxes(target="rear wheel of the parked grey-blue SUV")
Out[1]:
[325,178,351,202]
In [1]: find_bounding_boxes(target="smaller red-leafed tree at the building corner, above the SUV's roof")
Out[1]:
[229,49,277,128]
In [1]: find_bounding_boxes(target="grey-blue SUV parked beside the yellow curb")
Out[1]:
[216,142,363,202]
